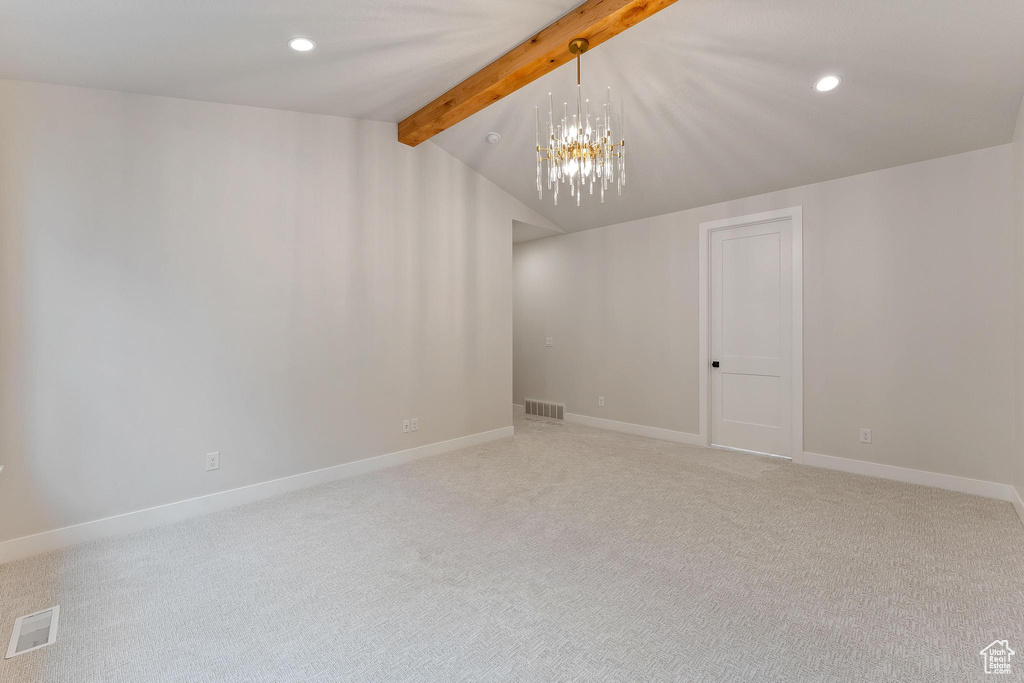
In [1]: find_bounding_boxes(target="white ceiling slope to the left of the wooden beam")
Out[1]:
[0,0,580,122]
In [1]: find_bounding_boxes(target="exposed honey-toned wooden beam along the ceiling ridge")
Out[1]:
[398,0,676,147]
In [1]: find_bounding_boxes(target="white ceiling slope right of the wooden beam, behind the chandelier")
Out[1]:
[435,0,1024,231]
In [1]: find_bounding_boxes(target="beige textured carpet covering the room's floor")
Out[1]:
[0,418,1024,683]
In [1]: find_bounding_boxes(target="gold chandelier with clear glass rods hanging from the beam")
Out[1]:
[536,38,626,206]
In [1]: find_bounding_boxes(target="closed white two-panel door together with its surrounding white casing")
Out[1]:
[699,207,803,462]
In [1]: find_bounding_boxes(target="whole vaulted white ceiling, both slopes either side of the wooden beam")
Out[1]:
[0,0,1024,230]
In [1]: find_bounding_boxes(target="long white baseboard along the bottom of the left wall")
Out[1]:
[0,427,514,564]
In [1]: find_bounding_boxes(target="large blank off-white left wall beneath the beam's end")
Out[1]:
[0,81,550,540]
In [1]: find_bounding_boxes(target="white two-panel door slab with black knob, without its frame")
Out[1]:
[710,218,794,456]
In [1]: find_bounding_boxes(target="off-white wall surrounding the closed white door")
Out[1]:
[513,144,1014,483]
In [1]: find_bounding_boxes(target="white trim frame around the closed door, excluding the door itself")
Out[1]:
[697,206,804,463]
